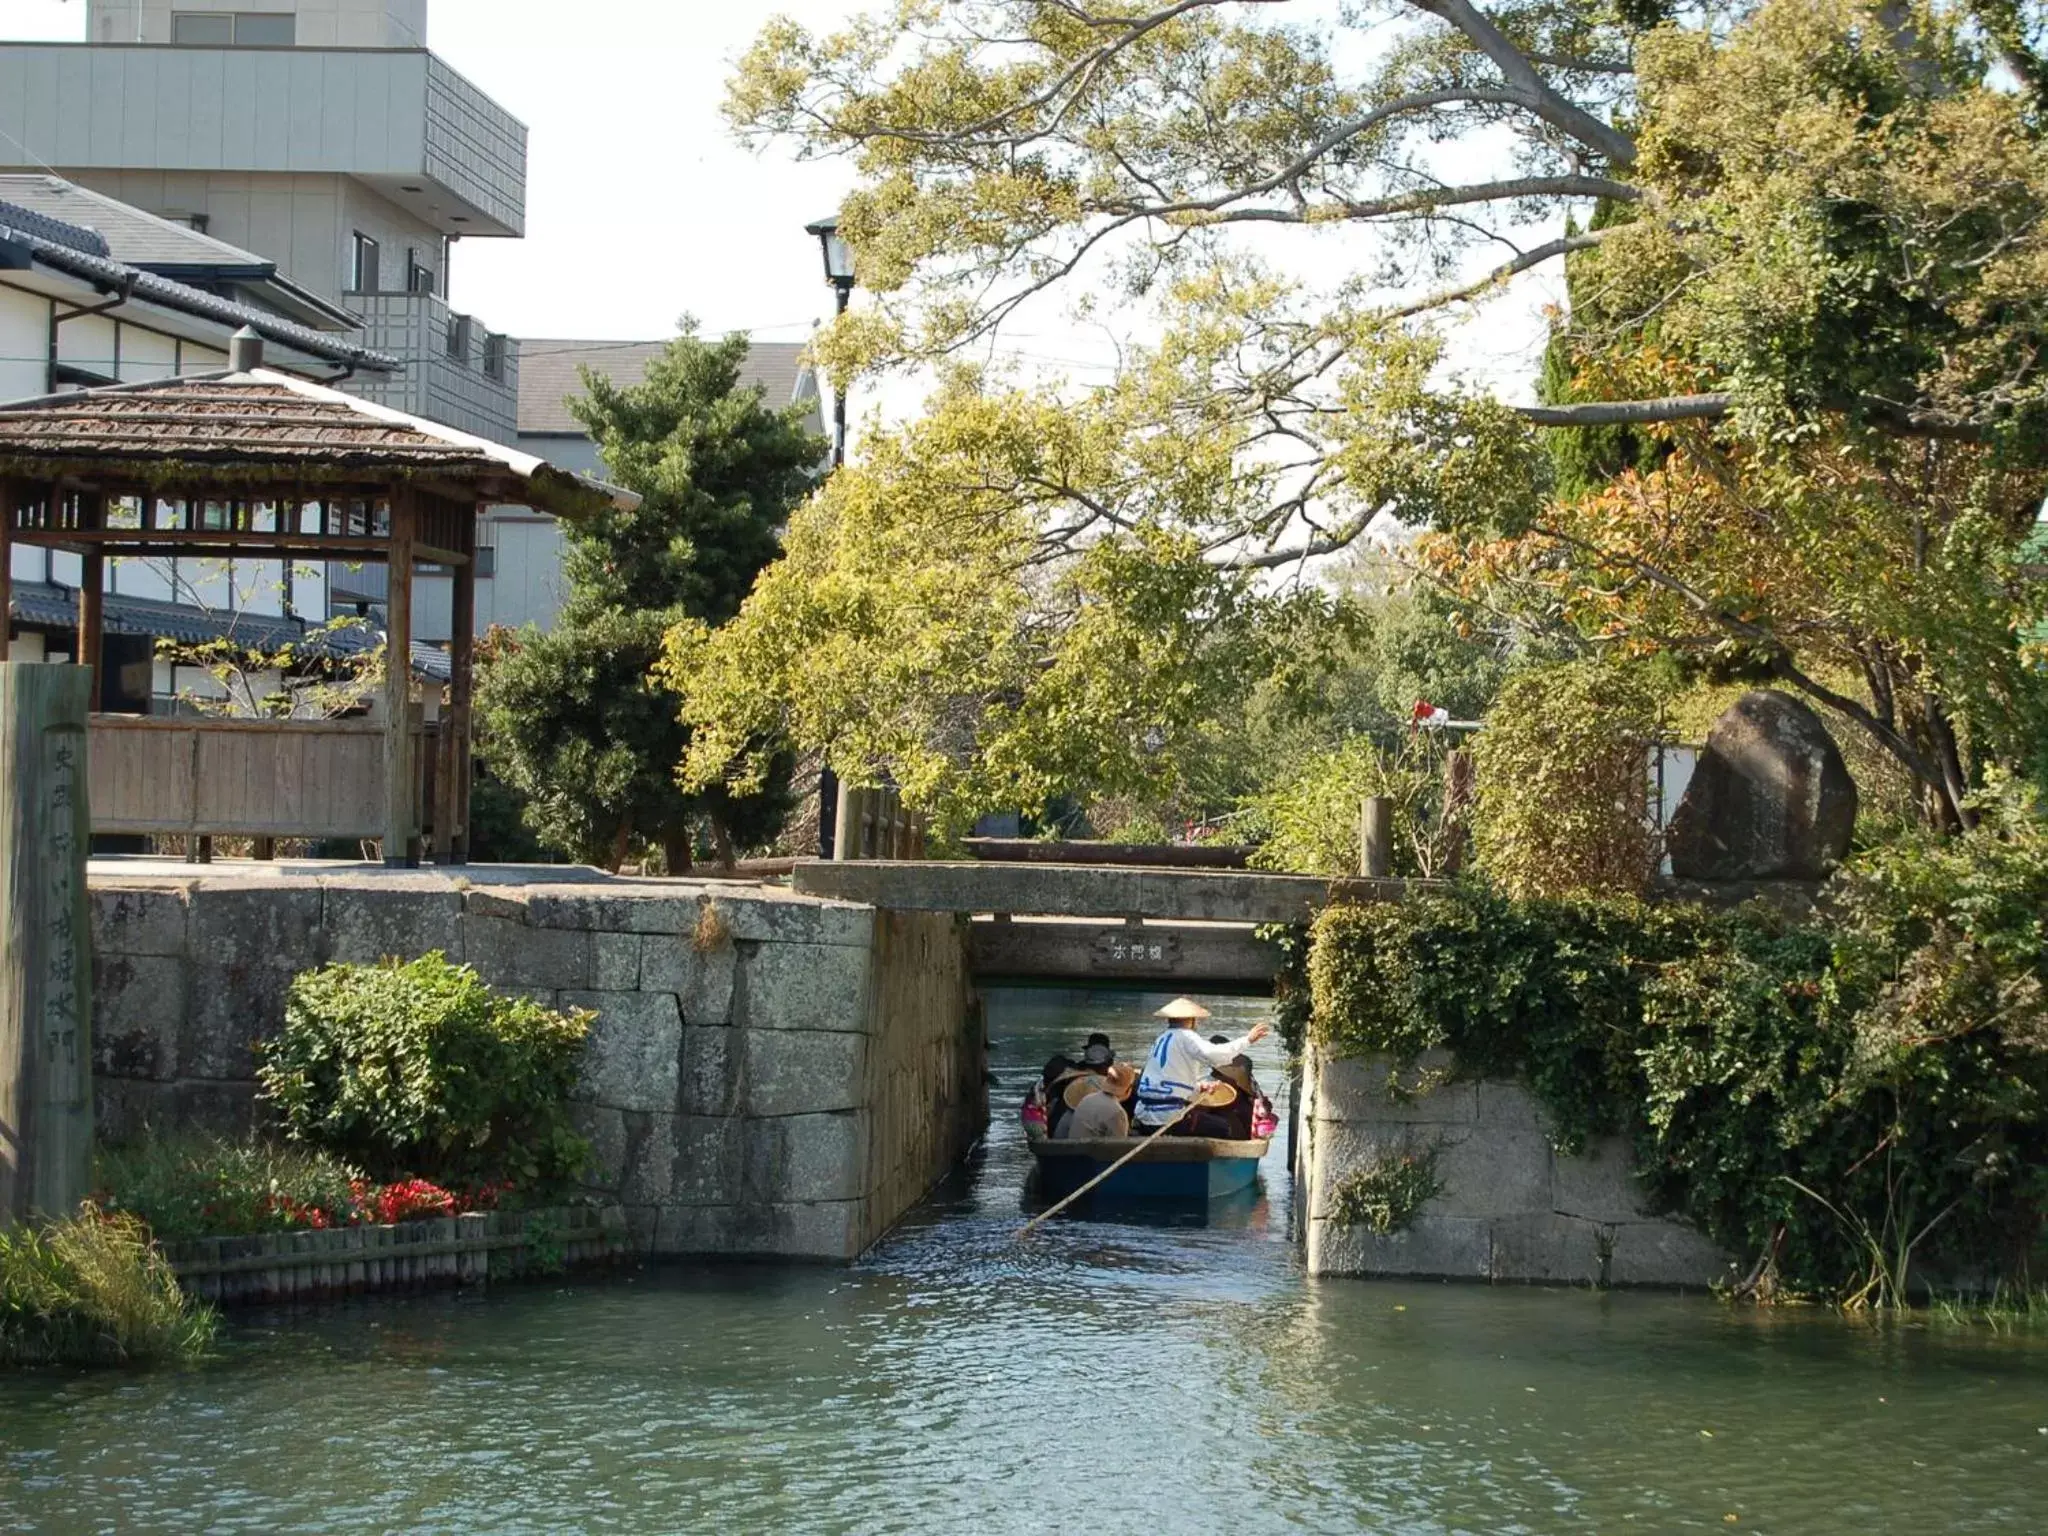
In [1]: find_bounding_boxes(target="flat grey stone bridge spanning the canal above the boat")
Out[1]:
[793,860,1411,991]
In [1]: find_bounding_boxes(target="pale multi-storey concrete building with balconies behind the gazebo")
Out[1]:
[0,0,526,440]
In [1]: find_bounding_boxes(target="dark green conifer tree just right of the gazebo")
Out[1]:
[477,324,825,872]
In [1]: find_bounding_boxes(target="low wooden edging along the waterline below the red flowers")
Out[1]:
[164,1206,629,1307]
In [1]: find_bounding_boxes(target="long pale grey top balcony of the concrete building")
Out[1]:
[0,43,526,236]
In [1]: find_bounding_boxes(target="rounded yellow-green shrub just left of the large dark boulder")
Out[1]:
[1473,659,1659,895]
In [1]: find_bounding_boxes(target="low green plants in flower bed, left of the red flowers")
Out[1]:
[94,1135,365,1243]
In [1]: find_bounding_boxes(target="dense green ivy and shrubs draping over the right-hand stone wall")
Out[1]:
[1309,793,2048,1305]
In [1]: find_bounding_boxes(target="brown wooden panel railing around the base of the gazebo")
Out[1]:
[88,715,438,840]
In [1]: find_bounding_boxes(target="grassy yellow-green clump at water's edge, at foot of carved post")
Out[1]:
[0,1206,215,1366]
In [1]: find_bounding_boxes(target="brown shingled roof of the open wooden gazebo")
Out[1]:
[0,369,639,518]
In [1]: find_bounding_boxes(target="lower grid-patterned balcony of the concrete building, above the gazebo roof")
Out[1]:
[342,293,518,442]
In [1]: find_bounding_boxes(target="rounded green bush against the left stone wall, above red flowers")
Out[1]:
[258,952,594,1184]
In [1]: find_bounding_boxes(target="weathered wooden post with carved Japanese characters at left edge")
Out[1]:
[0,662,92,1225]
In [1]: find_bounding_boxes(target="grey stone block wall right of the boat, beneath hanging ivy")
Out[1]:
[1294,1049,1735,1286]
